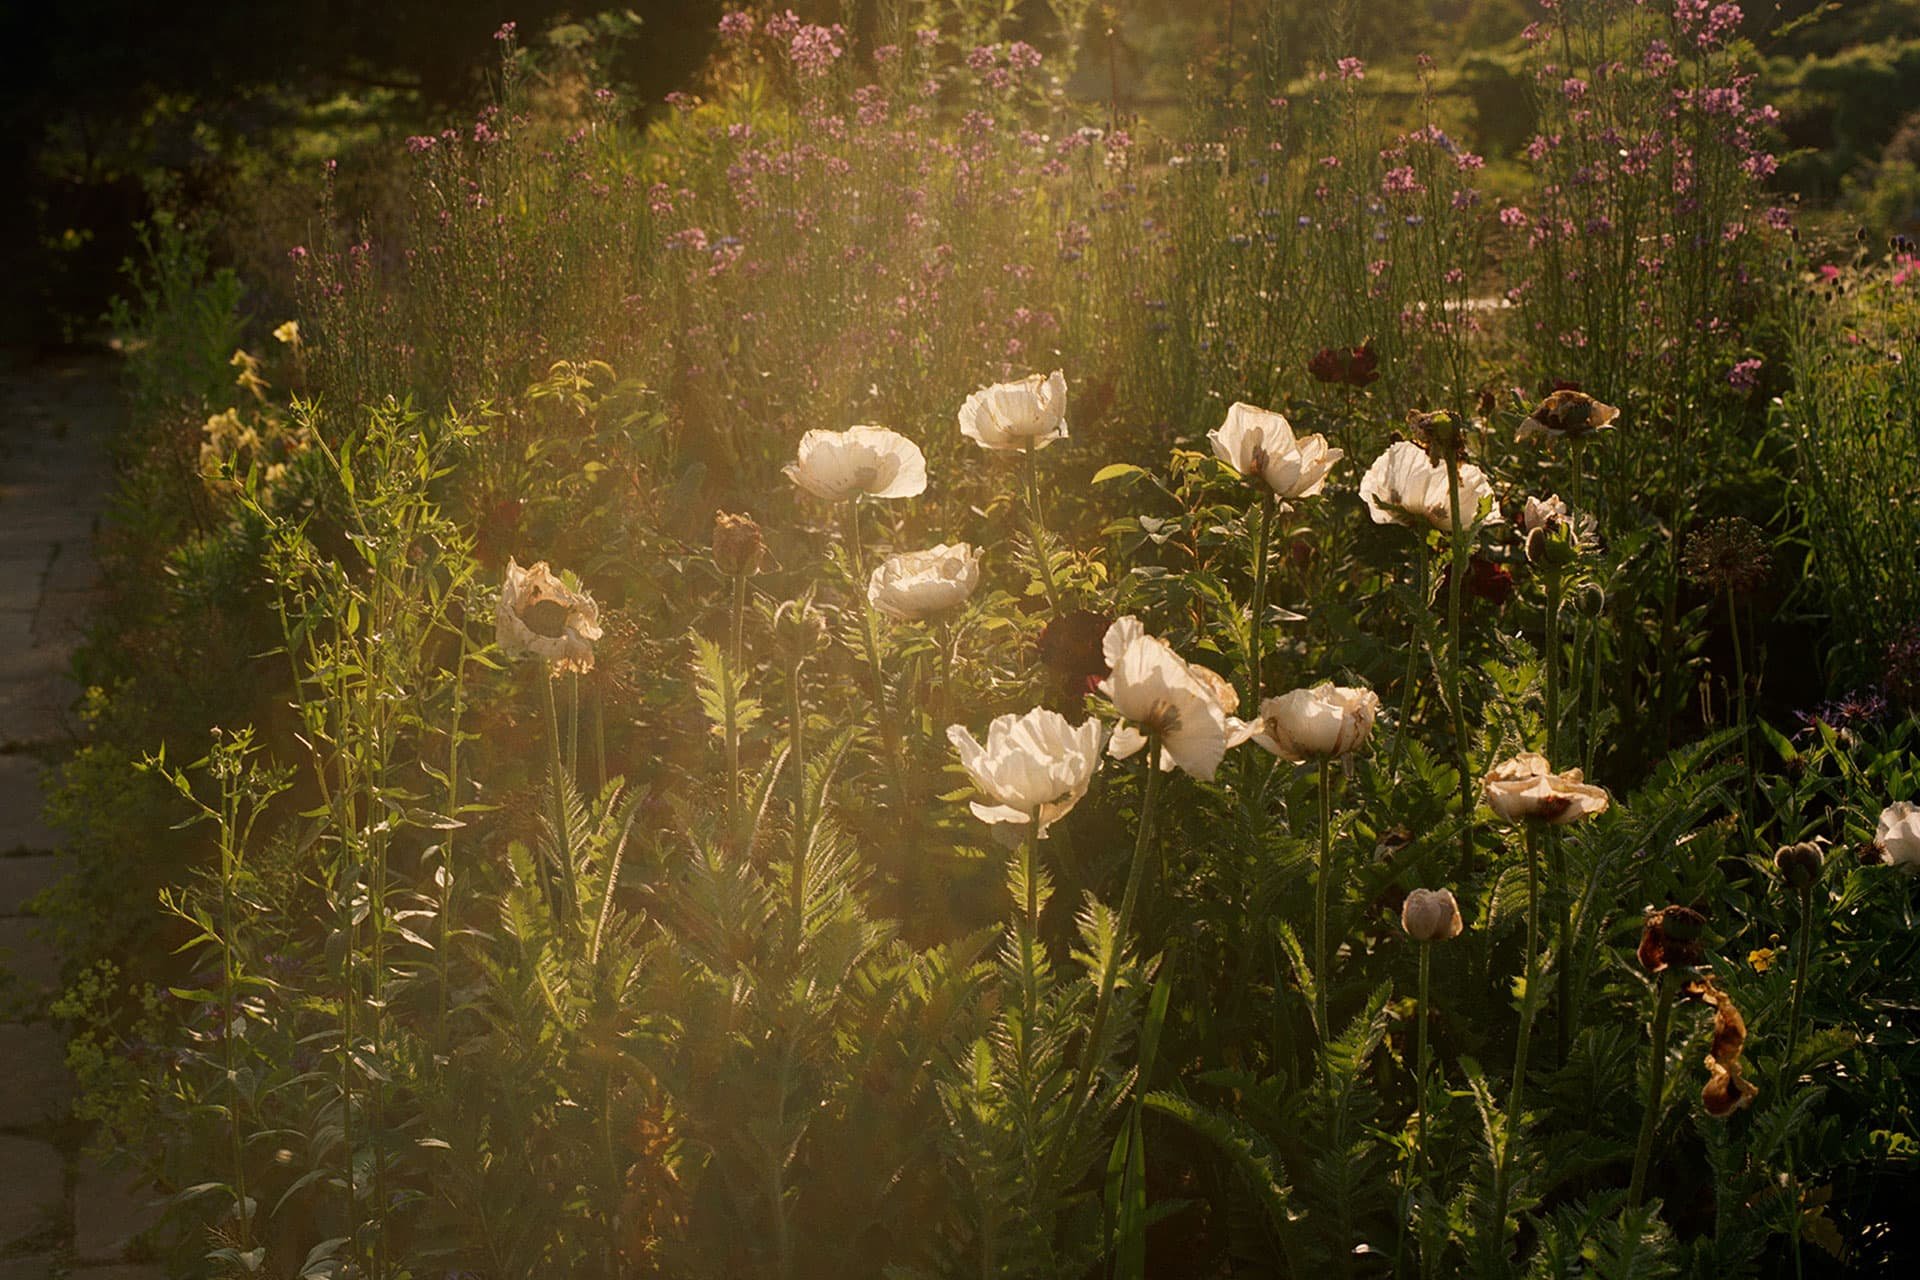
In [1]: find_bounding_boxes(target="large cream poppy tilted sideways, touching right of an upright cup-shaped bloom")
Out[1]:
[1100,616,1258,777]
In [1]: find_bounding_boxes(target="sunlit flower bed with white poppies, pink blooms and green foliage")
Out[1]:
[33,0,1920,1280]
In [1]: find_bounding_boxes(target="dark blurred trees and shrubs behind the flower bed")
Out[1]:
[0,0,1920,344]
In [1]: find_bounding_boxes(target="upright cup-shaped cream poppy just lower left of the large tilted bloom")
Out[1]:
[947,706,1106,841]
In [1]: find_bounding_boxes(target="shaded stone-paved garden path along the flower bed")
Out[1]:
[0,353,161,1280]
